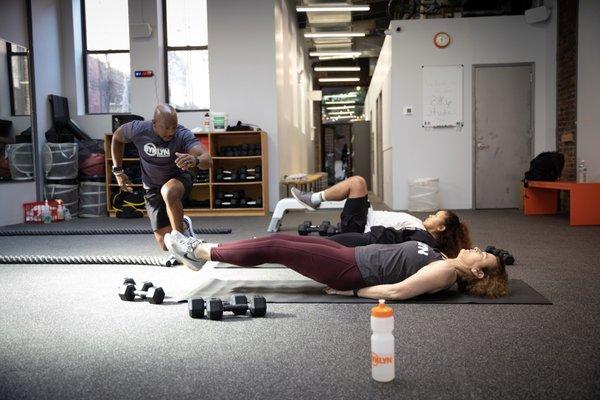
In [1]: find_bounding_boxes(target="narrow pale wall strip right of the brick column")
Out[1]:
[577,0,600,182]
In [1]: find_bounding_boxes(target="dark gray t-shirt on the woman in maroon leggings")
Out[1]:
[356,241,442,286]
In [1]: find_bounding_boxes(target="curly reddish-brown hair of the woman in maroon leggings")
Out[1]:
[457,256,508,298]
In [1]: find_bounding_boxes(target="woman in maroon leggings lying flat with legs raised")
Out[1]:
[165,231,508,300]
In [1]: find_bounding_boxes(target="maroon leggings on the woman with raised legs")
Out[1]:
[210,234,366,290]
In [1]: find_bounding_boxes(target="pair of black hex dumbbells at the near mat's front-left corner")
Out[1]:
[188,294,267,321]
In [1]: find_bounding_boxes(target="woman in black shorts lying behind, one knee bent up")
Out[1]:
[291,175,471,257]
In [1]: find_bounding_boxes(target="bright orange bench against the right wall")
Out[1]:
[523,181,600,225]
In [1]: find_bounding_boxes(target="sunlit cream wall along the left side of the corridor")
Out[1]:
[269,0,315,181]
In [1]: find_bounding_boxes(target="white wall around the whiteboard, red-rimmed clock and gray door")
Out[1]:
[368,13,556,209]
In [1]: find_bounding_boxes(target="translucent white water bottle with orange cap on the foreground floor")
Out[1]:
[371,300,395,382]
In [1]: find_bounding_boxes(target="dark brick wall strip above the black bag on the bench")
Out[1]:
[556,0,578,181]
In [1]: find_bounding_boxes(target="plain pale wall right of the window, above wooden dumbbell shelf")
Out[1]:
[208,0,279,209]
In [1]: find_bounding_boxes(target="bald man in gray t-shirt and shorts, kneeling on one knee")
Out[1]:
[111,104,212,250]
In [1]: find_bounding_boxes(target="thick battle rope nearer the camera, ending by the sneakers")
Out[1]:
[0,255,173,267]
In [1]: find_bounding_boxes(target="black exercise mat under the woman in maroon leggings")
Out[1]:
[186,279,552,304]
